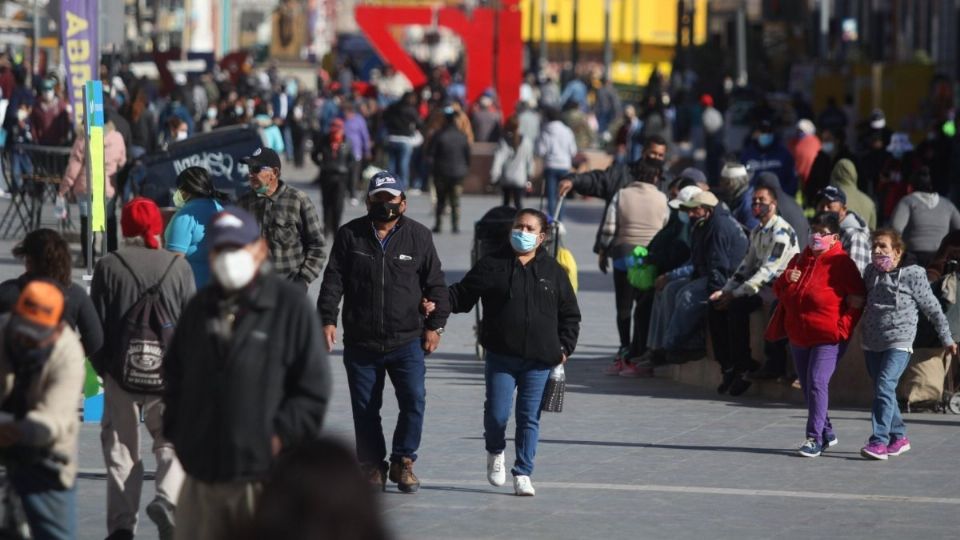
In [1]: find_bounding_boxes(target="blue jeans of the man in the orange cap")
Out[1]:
[9,465,77,540]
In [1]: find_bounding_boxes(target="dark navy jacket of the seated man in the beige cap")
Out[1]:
[690,206,748,293]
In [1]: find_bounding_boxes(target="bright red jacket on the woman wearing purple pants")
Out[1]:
[773,242,866,347]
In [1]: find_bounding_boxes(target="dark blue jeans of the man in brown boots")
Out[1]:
[343,339,426,465]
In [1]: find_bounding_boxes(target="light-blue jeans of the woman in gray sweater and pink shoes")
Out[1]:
[863,349,910,444]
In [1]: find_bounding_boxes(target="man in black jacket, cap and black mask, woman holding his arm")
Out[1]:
[317,171,450,493]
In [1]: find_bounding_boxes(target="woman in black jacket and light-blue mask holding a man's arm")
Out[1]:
[450,209,580,496]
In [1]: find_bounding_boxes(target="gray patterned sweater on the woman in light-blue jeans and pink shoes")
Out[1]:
[860,264,953,352]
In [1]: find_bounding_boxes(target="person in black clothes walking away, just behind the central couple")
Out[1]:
[425,107,470,234]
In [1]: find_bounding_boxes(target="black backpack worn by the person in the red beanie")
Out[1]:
[114,253,177,394]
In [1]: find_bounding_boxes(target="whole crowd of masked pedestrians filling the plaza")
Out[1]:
[0,48,960,539]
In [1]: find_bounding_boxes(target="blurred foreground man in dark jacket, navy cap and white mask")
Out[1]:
[163,208,330,539]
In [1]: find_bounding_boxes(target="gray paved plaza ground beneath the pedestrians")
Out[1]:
[0,166,960,540]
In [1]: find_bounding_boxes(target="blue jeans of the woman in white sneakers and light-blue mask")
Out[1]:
[483,351,550,476]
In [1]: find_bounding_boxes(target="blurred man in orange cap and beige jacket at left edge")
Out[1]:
[0,280,84,539]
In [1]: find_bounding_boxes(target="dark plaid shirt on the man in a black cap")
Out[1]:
[237,182,327,285]
